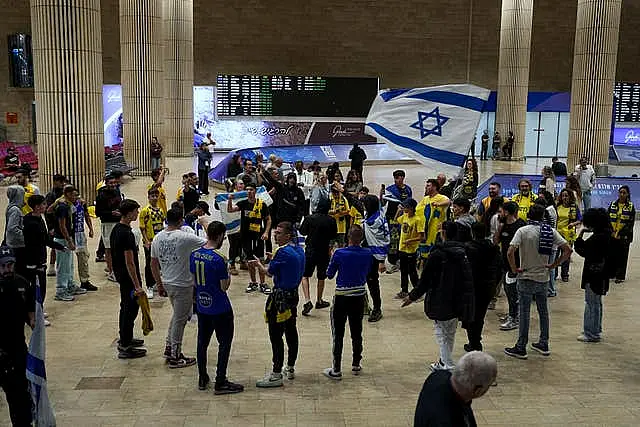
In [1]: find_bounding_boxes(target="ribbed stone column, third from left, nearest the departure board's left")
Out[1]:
[161,0,193,156]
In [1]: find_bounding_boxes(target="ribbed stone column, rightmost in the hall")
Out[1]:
[567,0,622,171]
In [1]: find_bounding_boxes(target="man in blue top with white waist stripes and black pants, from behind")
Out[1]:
[324,225,372,380]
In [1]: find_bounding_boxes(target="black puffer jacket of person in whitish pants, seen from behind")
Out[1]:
[409,241,475,322]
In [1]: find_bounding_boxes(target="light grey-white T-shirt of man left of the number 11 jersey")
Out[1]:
[151,230,207,288]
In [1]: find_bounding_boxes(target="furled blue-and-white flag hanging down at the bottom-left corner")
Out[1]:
[27,279,56,427]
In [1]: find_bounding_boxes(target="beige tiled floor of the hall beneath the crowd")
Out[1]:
[0,159,640,427]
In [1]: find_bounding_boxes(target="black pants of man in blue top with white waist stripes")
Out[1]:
[331,295,365,372]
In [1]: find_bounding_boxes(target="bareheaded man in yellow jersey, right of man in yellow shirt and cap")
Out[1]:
[416,179,451,258]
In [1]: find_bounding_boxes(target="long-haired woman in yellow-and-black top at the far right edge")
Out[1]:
[609,185,636,283]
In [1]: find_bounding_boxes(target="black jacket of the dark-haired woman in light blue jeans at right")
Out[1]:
[573,231,615,295]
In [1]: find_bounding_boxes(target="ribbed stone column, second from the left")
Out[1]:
[120,0,164,175]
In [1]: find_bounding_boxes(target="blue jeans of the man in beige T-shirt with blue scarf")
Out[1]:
[516,279,549,350]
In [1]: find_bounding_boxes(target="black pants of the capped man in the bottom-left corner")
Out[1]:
[0,351,32,427]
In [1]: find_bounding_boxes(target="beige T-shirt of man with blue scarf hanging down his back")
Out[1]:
[511,225,567,282]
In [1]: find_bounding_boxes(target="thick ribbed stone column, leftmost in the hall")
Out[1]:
[31,0,104,203]
